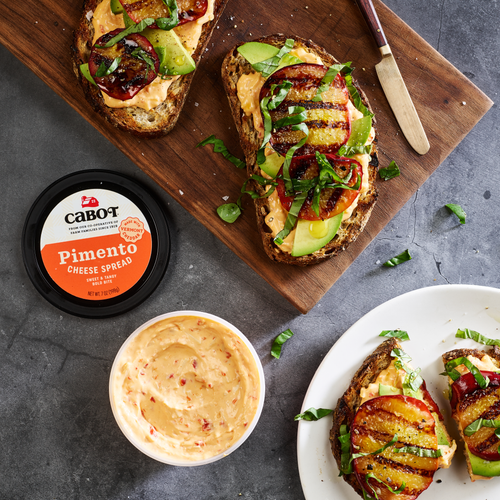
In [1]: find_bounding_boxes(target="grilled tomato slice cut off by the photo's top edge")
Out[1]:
[120,0,208,28]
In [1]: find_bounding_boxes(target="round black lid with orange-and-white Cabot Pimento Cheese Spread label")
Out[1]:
[23,170,170,318]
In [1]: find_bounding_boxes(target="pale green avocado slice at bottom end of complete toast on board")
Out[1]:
[292,212,343,257]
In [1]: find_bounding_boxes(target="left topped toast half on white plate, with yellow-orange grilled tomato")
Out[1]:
[330,338,456,500]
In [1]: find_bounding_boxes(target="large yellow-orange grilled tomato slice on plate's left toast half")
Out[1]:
[351,395,438,500]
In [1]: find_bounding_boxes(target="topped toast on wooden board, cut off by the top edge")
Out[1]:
[72,0,227,137]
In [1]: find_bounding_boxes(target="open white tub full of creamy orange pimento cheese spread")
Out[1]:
[109,311,265,466]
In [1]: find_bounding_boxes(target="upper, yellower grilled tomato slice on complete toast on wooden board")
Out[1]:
[260,64,351,156]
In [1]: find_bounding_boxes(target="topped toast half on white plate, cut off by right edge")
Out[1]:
[443,345,500,481]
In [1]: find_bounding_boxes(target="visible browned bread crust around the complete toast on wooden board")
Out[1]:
[222,34,378,266]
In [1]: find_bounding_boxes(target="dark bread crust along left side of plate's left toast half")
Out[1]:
[330,338,401,496]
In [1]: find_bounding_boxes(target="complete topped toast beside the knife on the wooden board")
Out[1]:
[222,34,378,266]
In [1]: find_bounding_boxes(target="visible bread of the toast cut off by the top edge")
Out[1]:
[71,0,227,138]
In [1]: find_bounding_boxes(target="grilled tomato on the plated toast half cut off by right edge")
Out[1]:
[451,371,500,461]
